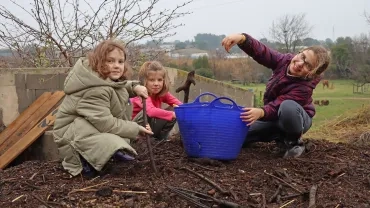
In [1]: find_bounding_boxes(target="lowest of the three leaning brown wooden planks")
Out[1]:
[0,106,59,169]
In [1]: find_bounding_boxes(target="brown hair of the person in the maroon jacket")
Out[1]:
[303,45,331,79]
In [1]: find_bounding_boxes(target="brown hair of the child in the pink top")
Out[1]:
[139,61,170,96]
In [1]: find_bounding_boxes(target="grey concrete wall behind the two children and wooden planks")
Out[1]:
[0,68,254,161]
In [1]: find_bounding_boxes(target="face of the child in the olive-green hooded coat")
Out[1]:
[106,48,125,80]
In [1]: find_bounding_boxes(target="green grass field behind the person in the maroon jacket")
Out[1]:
[233,80,370,140]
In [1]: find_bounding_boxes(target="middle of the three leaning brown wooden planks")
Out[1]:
[0,91,64,155]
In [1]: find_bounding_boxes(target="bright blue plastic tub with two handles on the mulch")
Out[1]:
[174,93,249,160]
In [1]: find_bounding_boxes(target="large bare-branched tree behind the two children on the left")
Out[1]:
[0,0,193,66]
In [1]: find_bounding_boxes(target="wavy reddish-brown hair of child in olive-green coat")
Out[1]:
[87,40,130,80]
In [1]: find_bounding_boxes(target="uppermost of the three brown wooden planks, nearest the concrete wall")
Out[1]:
[0,92,51,145]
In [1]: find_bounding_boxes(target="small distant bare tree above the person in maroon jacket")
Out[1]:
[270,14,312,52]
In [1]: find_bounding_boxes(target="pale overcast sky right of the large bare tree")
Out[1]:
[0,0,370,41]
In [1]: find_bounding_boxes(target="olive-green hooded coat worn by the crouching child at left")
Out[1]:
[53,58,139,176]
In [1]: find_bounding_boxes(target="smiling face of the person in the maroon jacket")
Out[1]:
[289,50,317,77]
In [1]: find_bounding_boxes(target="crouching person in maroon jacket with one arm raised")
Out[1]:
[222,33,331,157]
